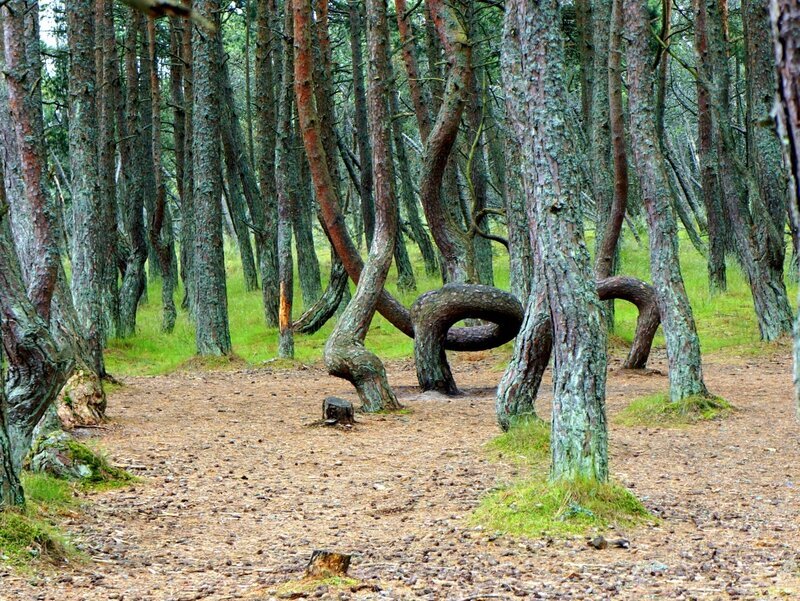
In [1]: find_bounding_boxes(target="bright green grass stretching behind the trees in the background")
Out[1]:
[106,232,797,375]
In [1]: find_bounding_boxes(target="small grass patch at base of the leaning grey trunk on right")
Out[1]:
[614,393,734,428]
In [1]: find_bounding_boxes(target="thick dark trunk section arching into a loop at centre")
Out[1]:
[411,284,523,395]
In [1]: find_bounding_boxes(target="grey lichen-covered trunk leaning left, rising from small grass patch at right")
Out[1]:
[624,0,708,401]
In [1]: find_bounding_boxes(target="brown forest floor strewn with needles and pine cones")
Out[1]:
[0,346,800,601]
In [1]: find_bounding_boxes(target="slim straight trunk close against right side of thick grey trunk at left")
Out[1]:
[95,0,121,338]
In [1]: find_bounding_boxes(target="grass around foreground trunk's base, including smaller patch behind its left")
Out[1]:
[471,418,653,537]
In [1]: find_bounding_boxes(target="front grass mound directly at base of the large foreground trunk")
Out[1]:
[473,473,653,537]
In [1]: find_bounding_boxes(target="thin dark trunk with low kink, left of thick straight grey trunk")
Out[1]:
[147,17,177,333]
